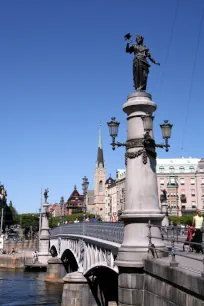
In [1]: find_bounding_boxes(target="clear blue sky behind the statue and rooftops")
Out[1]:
[0,0,204,212]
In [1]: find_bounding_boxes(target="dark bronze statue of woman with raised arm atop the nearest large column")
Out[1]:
[125,33,160,91]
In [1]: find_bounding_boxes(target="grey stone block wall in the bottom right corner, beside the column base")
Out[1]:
[144,259,204,306]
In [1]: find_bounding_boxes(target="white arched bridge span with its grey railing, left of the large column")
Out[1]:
[50,222,124,275]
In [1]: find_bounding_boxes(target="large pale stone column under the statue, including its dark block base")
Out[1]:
[116,91,164,306]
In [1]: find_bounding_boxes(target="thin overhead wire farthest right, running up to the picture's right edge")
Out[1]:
[181,8,204,150]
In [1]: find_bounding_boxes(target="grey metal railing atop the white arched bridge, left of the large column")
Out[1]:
[50,222,124,243]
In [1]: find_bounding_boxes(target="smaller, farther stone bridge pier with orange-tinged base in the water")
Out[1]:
[45,257,66,283]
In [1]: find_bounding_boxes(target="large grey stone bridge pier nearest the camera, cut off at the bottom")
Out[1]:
[61,272,97,306]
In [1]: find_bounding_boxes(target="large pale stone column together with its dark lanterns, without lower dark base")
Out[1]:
[107,91,173,268]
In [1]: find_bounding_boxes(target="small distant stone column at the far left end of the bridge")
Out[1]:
[38,203,51,264]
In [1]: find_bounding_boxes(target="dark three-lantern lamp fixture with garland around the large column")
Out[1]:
[107,115,173,164]
